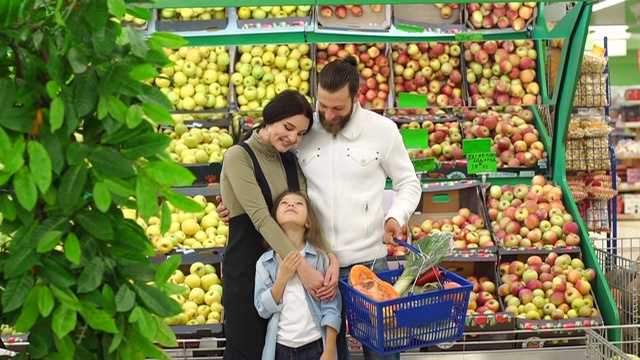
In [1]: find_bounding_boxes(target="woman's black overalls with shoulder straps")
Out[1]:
[222,143,300,360]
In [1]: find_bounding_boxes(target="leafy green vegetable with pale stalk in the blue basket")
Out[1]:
[393,231,453,296]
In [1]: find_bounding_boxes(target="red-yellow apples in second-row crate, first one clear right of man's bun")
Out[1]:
[391,42,463,107]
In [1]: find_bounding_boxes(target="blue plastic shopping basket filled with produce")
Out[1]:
[340,240,473,354]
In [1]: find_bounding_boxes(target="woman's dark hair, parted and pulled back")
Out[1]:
[242,90,313,141]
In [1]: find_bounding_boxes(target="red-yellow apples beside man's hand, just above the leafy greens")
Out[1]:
[410,208,494,249]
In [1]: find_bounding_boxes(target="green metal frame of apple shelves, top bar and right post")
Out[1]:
[146,0,620,341]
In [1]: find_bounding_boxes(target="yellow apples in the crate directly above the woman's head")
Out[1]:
[231,44,313,111]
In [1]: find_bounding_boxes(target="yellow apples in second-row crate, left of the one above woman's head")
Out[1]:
[154,46,231,111]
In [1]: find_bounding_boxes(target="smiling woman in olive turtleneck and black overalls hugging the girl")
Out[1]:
[220,90,339,360]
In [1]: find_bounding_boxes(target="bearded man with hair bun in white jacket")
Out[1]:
[218,57,421,360]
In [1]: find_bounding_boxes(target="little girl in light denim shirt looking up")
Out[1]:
[254,191,341,360]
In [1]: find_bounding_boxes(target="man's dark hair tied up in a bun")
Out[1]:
[318,56,360,97]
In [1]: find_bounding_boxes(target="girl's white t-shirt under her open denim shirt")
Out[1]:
[276,250,322,348]
